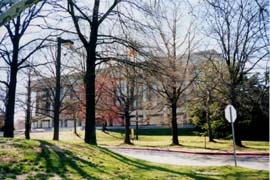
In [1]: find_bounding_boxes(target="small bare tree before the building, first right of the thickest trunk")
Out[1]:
[97,59,142,144]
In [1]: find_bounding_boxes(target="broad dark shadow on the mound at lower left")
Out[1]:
[33,140,104,180]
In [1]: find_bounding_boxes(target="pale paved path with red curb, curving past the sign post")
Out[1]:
[107,146,269,170]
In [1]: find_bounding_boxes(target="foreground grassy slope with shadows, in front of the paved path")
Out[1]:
[0,137,268,180]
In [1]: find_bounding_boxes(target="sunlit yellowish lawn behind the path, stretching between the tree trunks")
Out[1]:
[19,130,269,151]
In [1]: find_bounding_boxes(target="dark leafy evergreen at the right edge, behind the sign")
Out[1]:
[237,72,269,140]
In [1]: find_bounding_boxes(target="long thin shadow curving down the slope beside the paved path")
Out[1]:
[100,147,214,180]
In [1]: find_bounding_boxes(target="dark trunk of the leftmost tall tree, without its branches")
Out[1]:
[4,65,18,138]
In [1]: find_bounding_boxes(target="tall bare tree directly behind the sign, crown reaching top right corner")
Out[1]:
[205,0,269,146]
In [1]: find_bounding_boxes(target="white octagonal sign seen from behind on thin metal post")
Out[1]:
[225,104,237,166]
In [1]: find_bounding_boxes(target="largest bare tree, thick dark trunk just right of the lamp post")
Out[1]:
[46,0,146,144]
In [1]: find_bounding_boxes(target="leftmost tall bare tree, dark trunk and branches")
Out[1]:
[0,2,45,137]
